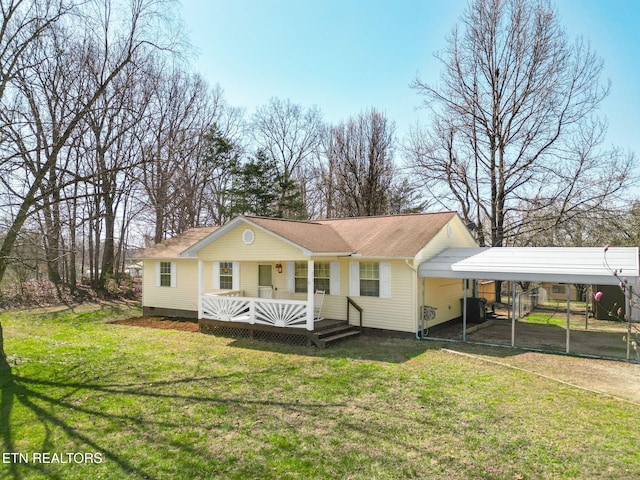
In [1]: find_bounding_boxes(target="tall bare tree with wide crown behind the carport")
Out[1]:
[406,0,634,246]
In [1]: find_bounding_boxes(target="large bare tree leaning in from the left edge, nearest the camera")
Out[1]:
[0,0,179,364]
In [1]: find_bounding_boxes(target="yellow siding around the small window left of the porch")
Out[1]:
[142,259,198,311]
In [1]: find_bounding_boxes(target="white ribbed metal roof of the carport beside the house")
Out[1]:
[418,247,640,285]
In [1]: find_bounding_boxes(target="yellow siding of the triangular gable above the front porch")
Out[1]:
[199,224,306,260]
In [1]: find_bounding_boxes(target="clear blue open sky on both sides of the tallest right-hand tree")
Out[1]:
[176,0,640,155]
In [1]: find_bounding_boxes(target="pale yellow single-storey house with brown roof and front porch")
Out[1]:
[137,212,477,344]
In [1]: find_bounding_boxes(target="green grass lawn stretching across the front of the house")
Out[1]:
[0,304,640,480]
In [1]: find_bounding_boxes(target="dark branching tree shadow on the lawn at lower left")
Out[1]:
[0,368,340,480]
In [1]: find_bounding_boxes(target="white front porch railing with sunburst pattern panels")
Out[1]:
[201,294,313,330]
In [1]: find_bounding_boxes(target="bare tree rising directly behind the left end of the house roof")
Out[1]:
[140,64,224,242]
